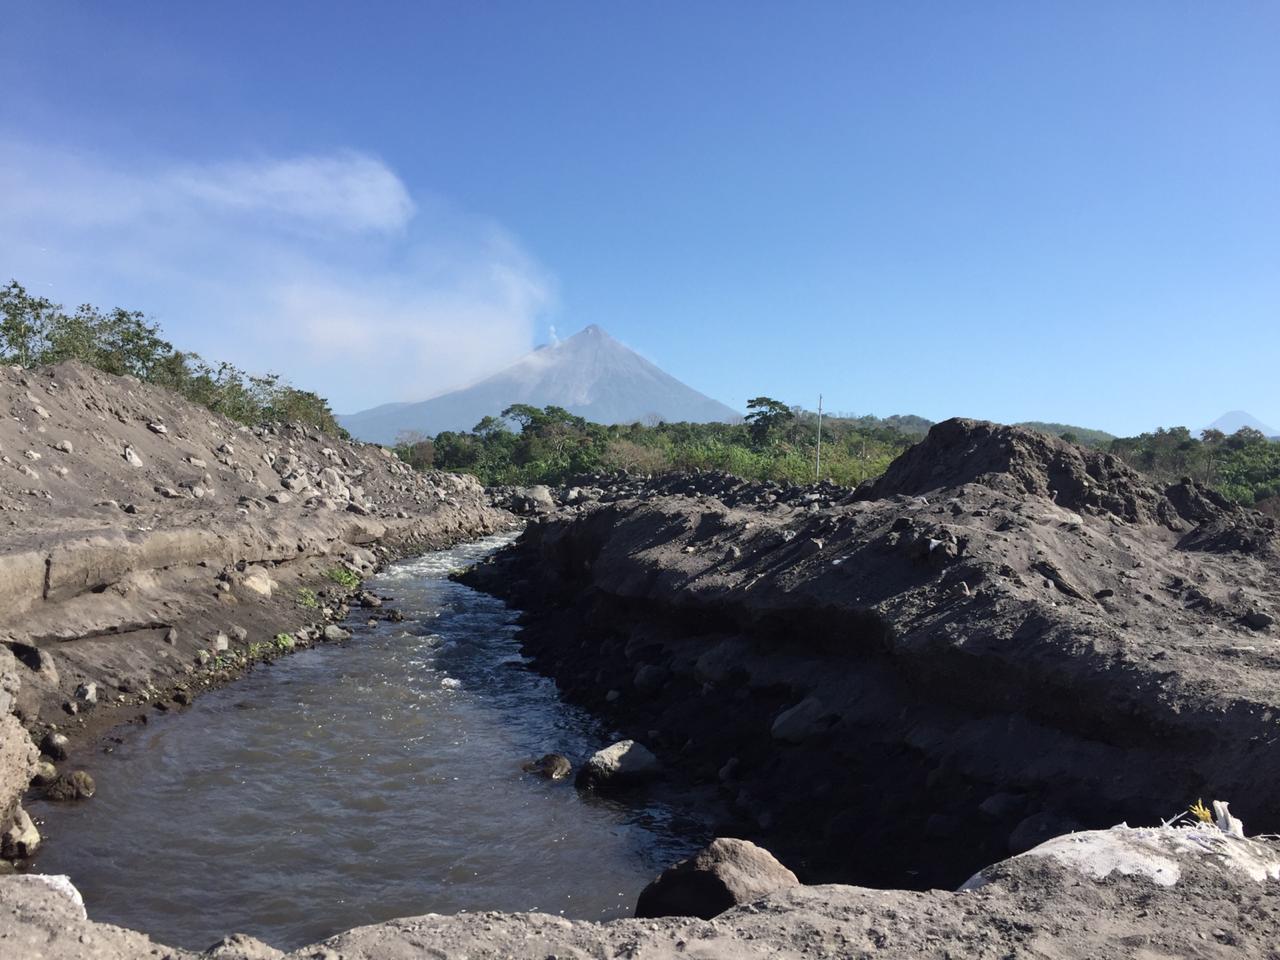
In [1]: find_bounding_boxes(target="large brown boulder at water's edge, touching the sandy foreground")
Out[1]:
[636,837,800,920]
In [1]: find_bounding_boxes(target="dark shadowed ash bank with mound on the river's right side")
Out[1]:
[467,420,1280,888]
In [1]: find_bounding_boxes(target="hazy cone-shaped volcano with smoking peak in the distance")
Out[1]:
[338,325,741,443]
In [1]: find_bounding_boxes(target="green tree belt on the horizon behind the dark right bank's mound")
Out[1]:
[396,397,1280,509]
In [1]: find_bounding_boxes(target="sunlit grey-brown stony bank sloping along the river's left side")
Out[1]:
[0,364,511,859]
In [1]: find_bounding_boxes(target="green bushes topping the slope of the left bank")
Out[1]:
[0,280,347,436]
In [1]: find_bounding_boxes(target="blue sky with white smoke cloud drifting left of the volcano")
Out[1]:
[0,0,1280,433]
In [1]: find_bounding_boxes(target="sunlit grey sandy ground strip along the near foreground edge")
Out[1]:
[0,824,1280,960]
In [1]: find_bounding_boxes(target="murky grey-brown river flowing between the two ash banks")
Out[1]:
[33,538,698,948]
